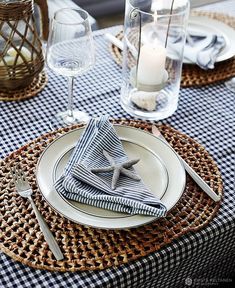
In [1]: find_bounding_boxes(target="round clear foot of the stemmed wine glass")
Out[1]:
[50,110,90,130]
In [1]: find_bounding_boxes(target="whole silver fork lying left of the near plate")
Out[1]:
[11,167,64,260]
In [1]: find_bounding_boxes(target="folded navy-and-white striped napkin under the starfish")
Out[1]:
[55,116,166,217]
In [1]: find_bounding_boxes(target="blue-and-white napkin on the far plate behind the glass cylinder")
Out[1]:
[184,32,226,70]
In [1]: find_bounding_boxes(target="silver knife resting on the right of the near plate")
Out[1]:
[152,125,221,202]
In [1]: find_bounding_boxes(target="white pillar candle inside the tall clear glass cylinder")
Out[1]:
[137,44,166,85]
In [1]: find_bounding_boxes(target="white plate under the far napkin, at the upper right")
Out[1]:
[183,16,235,64]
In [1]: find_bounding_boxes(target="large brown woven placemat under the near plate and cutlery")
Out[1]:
[0,120,223,271]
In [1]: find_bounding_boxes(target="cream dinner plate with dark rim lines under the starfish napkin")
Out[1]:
[36,125,186,229]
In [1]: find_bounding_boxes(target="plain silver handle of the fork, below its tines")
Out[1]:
[29,197,64,260]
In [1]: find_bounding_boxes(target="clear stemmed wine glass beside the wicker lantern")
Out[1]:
[46,8,95,128]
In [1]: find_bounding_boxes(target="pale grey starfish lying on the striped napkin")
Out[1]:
[91,150,141,190]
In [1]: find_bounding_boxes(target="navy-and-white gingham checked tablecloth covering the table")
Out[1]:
[0,1,235,288]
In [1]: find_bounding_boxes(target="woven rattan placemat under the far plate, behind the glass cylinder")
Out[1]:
[110,11,235,87]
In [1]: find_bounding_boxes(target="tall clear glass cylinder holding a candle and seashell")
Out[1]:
[121,0,189,120]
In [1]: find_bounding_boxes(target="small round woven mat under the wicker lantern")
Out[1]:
[0,71,47,101]
